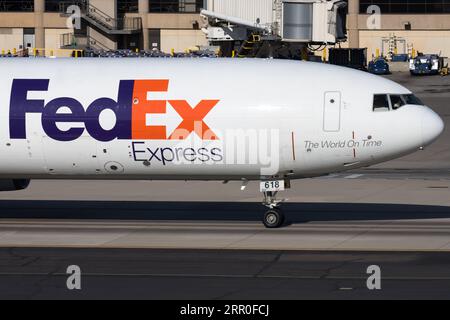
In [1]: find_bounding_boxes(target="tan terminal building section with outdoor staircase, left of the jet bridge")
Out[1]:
[0,0,206,52]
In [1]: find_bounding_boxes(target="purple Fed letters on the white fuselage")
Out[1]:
[9,79,134,142]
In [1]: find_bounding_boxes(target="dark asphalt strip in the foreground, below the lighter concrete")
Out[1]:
[0,248,450,300]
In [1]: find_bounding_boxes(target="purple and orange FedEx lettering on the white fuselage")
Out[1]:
[9,79,220,142]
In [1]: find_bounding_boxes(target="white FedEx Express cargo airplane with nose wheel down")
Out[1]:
[0,58,444,228]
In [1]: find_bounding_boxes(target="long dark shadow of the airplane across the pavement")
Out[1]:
[0,200,450,223]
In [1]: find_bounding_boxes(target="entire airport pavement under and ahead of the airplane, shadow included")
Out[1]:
[0,74,450,299]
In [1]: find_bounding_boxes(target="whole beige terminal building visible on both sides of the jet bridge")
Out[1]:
[0,0,450,59]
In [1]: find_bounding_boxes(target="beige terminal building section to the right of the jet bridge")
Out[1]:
[347,0,450,57]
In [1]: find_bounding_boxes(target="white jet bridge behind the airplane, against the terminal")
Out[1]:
[201,0,347,56]
